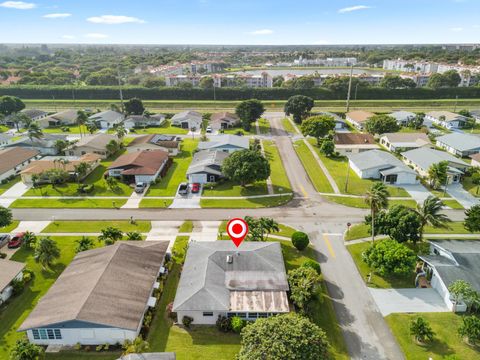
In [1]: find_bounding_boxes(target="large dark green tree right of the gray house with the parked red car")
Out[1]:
[222,150,270,187]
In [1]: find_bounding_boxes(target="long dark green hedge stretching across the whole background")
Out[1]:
[0,85,480,101]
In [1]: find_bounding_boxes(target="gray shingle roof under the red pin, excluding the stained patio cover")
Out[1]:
[173,241,288,311]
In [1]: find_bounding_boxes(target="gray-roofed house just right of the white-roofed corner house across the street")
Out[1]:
[401,148,470,183]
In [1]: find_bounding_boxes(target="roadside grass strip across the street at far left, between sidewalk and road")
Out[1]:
[10,198,127,209]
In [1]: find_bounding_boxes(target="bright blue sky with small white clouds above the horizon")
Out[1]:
[0,0,480,45]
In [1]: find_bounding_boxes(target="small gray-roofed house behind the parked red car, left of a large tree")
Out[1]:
[187,150,229,184]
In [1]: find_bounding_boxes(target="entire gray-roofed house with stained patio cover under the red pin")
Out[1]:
[173,241,290,325]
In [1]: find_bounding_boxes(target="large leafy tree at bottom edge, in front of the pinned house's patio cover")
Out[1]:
[237,313,329,360]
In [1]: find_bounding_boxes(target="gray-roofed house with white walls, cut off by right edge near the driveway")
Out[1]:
[417,240,480,312]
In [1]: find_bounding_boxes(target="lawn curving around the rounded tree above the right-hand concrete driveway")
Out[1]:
[347,242,415,288]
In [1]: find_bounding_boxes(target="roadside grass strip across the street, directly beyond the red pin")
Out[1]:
[200,195,292,209]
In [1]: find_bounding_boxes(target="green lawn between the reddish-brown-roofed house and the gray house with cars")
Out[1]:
[146,139,198,196]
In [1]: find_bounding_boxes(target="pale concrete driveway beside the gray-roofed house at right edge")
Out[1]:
[368,288,450,316]
